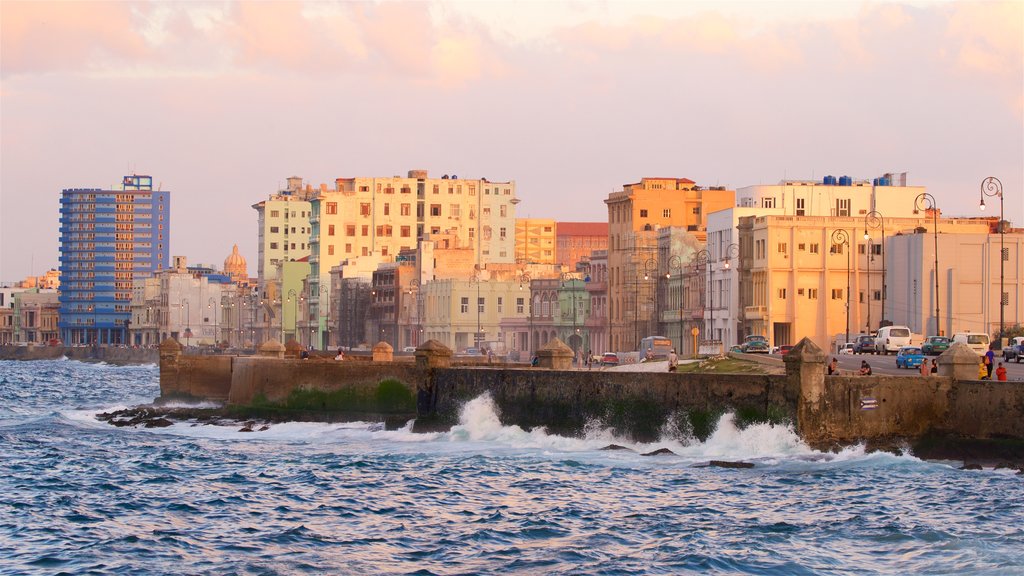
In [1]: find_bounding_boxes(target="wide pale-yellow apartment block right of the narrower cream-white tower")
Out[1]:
[309,170,519,348]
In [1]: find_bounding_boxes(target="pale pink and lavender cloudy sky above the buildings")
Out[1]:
[0,0,1024,282]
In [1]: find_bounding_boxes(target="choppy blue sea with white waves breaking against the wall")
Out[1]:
[0,360,1024,575]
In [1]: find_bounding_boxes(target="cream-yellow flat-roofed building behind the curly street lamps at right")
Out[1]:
[730,213,987,349]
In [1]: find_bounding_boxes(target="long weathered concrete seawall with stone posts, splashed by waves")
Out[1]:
[160,340,1024,447]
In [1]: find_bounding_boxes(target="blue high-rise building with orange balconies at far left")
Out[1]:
[58,174,171,344]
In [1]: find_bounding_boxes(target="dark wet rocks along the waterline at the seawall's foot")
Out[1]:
[96,405,1024,476]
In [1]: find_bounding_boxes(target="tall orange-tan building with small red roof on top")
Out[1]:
[604,178,736,352]
